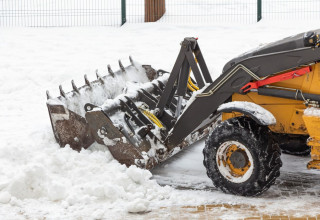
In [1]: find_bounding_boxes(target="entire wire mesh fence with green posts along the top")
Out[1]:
[0,0,320,27]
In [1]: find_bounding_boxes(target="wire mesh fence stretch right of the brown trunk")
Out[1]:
[141,0,320,24]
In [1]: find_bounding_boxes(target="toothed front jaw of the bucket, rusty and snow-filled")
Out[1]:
[47,57,161,151]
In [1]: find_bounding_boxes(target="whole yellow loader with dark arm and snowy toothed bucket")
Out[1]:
[47,30,320,196]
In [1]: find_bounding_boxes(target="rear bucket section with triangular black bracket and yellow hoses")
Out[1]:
[85,38,217,169]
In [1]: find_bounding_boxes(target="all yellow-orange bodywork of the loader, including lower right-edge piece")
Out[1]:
[222,63,320,169]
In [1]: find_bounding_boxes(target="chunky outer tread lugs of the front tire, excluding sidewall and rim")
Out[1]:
[203,117,282,196]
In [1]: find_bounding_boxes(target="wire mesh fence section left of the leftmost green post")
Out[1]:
[0,0,125,27]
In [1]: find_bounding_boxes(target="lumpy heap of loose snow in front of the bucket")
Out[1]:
[0,142,172,216]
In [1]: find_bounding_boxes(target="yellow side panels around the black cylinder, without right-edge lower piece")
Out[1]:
[222,64,320,135]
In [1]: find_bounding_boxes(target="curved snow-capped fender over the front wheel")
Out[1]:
[218,101,276,125]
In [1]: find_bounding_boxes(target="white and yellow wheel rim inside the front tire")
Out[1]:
[216,141,253,183]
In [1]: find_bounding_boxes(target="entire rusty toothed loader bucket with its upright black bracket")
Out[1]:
[47,38,220,169]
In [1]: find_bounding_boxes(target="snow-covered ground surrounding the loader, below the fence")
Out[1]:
[0,21,320,219]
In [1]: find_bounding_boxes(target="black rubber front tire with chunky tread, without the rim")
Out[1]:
[203,117,282,196]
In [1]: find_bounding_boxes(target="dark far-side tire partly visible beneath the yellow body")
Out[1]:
[276,134,311,156]
